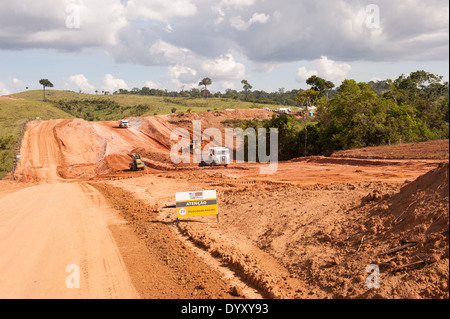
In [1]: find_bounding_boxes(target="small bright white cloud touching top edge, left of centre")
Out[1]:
[126,0,197,22]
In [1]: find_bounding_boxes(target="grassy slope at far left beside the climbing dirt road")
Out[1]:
[0,100,73,179]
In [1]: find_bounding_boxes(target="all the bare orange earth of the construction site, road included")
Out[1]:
[0,110,448,299]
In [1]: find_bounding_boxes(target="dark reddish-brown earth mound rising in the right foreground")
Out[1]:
[338,162,449,298]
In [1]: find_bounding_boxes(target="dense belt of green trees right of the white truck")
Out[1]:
[232,71,449,160]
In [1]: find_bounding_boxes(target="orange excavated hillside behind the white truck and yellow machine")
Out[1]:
[14,110,278,180]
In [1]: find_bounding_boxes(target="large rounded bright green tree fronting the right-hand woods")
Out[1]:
[317,80,398,151]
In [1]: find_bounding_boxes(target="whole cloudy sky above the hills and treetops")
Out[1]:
[0,0,449,95]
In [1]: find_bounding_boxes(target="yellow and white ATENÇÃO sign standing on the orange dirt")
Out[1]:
[175,190,219,218]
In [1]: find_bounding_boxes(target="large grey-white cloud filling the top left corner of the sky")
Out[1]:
[0,0,128,51]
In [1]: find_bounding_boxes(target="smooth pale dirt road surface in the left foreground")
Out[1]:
[0,183,139,298]
